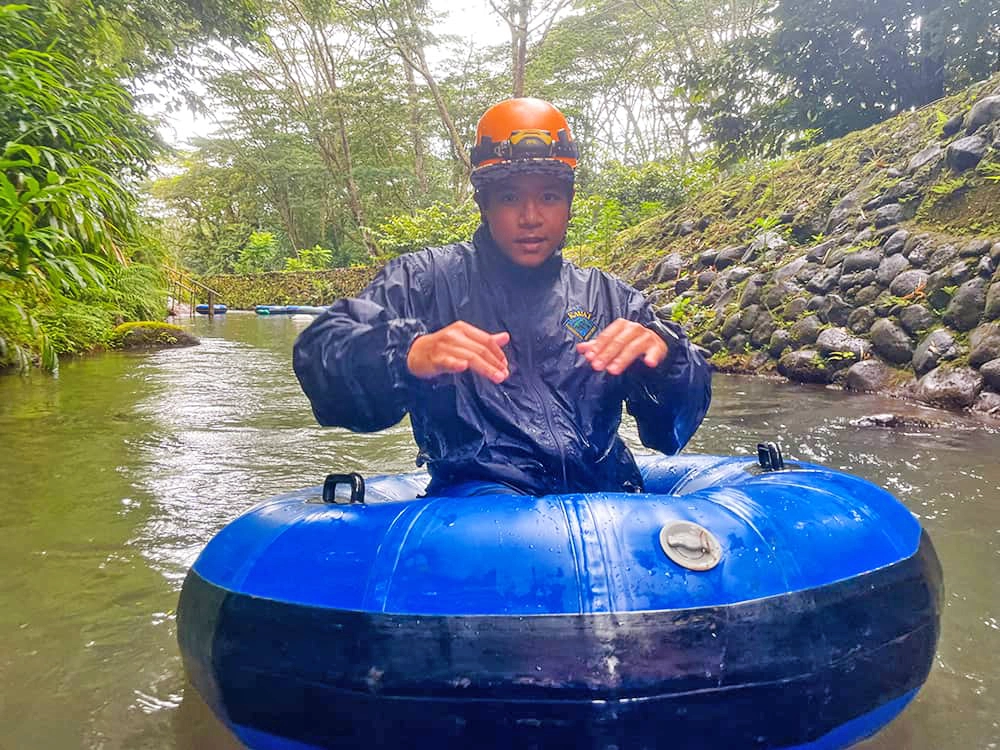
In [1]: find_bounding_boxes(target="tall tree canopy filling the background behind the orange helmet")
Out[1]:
[154,0,1000,271]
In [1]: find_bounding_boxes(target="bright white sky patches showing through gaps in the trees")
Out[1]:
[142,0,510,147]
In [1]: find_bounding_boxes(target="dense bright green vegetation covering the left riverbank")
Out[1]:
[0,0,256,369]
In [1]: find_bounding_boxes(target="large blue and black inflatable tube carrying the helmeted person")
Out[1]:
[178,456,942,750]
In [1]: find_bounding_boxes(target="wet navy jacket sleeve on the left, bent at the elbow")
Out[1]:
[292,258,427,432]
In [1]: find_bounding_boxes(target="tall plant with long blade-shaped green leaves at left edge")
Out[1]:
[0,5,156,369]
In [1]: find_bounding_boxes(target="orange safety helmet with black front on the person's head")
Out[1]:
[471,97,579,190]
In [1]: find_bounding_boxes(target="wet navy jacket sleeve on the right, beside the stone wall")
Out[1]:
[625,290,712,455]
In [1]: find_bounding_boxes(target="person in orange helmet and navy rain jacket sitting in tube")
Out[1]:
[294,98,711,495]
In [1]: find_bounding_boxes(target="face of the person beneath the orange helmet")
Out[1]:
[481,174,573,268]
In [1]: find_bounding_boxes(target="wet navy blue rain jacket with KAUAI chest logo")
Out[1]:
[294,226,711,495]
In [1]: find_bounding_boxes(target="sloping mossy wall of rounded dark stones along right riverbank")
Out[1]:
[627,79,1000,415]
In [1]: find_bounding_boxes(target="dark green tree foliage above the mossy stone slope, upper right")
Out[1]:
[684,0,1000,161]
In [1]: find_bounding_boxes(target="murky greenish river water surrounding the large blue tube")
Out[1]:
[0,313,1000,750]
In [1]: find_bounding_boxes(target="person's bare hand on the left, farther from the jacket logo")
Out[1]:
[406,320,510,383]
